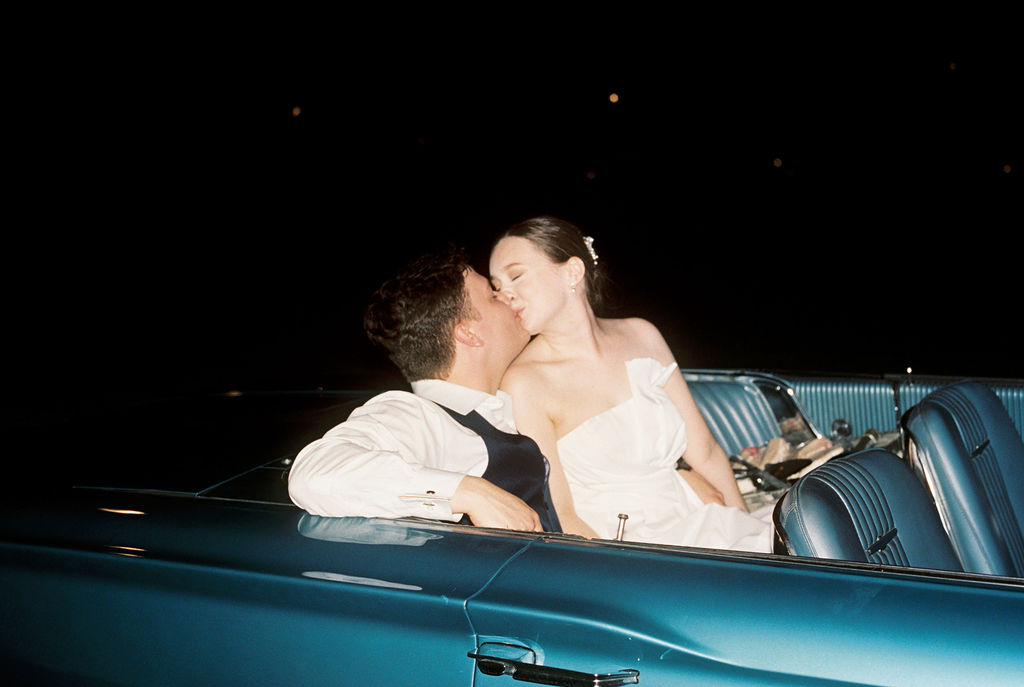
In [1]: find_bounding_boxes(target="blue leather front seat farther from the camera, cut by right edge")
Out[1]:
[903,381,1024,577]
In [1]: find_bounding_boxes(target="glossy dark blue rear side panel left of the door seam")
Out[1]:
[6,492,528,685]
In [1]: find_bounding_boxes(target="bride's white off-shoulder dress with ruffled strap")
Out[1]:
[558,358,771,553]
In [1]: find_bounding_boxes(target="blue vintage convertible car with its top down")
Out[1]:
[0,371,1024,687]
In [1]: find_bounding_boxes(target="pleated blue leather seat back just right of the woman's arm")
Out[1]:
[687,380,781,456]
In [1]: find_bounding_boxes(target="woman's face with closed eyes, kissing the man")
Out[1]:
[490,237,572,334]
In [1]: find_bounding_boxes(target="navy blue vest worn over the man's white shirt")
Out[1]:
[441,405,562,532]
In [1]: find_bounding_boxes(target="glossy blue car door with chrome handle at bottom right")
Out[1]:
[468,539,1024,687]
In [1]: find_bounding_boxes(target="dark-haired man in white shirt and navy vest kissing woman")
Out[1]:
[289,245,560,531]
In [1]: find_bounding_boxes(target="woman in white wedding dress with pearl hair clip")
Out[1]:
[490,216,771,552]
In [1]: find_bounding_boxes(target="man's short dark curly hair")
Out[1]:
[362,247,479,382]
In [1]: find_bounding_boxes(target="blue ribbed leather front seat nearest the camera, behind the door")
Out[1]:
[774,448,962,570]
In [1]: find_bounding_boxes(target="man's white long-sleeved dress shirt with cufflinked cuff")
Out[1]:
[288,380,516,520]
